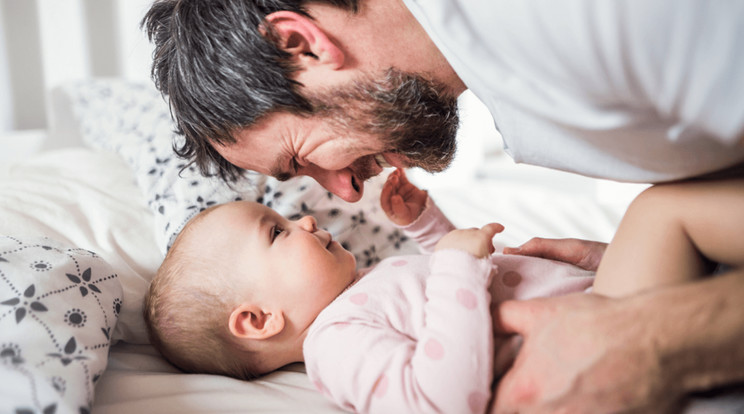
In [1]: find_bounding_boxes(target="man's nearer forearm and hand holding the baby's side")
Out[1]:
[493,269,744,413]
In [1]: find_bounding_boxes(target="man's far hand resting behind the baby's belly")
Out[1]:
[504,237,607,271]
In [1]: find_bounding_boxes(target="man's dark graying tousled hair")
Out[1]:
[141,0,359,182]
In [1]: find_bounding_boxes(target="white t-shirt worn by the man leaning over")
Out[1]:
[404,0,744,182]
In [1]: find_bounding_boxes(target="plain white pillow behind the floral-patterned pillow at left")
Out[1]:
[0,148,162,343]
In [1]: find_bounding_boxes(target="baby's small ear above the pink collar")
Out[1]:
[228,303,284,340]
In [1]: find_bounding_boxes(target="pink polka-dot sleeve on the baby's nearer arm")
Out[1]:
[418,250,494,413]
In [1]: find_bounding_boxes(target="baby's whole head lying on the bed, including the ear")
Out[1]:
[145,201,356,379]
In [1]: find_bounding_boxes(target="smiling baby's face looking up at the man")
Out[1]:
[200,201,356,326]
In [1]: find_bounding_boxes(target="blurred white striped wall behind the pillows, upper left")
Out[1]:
[0,0,151,134]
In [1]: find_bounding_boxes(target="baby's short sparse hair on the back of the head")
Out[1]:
[144,206,263,380]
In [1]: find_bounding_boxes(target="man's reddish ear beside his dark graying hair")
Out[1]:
[266,11,345,70]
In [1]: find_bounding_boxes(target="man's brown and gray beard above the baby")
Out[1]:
[308,69,459,178]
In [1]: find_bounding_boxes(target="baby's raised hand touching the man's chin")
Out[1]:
[380,169,428,226]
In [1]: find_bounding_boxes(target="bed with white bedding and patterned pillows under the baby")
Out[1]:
[0,3,744,414]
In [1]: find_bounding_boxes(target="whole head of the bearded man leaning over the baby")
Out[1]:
[143,0,458,201]
